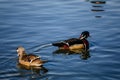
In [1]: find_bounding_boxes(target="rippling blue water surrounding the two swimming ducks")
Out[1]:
[0,0,120,80]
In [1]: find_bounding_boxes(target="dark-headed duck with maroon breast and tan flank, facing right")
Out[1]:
[52,31,90,50]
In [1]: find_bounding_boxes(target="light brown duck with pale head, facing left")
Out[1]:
[17,46,46,67]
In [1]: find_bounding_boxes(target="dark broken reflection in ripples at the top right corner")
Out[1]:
[90,0,106,18]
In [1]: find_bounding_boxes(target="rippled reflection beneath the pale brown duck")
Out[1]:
[17,63,48,79]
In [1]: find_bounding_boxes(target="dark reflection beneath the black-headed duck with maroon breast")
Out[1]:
[53,49,90,60]
